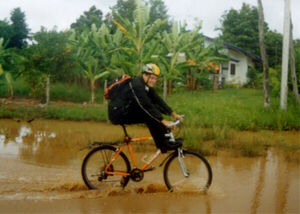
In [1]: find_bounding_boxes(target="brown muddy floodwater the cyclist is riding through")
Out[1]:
[0,120,300,213]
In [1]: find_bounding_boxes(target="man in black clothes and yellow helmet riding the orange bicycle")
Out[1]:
[109,64,183,153]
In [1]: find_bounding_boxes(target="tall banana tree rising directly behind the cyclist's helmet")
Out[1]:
[111,0,166,75]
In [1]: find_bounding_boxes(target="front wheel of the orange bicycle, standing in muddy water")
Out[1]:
[164,150,212,192]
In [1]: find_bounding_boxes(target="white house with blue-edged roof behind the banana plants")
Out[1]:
[204,36,260,85]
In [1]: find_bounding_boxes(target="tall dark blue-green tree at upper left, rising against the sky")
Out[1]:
[8,7,29,48]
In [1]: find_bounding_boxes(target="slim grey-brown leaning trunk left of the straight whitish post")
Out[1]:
[257,0,270,108]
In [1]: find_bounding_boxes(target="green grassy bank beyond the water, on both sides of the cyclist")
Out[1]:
[0,86,300,131]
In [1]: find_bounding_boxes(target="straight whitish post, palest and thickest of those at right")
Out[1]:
[280,0,291,110]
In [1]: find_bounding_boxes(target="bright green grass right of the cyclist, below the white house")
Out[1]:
[168,89,300,131]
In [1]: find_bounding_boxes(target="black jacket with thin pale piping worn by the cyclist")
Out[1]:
[129,76,173,121]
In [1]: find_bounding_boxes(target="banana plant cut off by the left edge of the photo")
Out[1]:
[0,38,14,98]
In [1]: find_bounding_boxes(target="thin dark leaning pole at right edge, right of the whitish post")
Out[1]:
[290,20,299,103]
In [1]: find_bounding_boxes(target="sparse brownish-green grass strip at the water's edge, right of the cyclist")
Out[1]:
[183,127,300,163]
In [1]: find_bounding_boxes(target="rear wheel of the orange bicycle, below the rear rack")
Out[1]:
[81,146,130,189]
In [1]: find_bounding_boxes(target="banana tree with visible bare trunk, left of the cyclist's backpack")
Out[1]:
[70,24,126,104]
